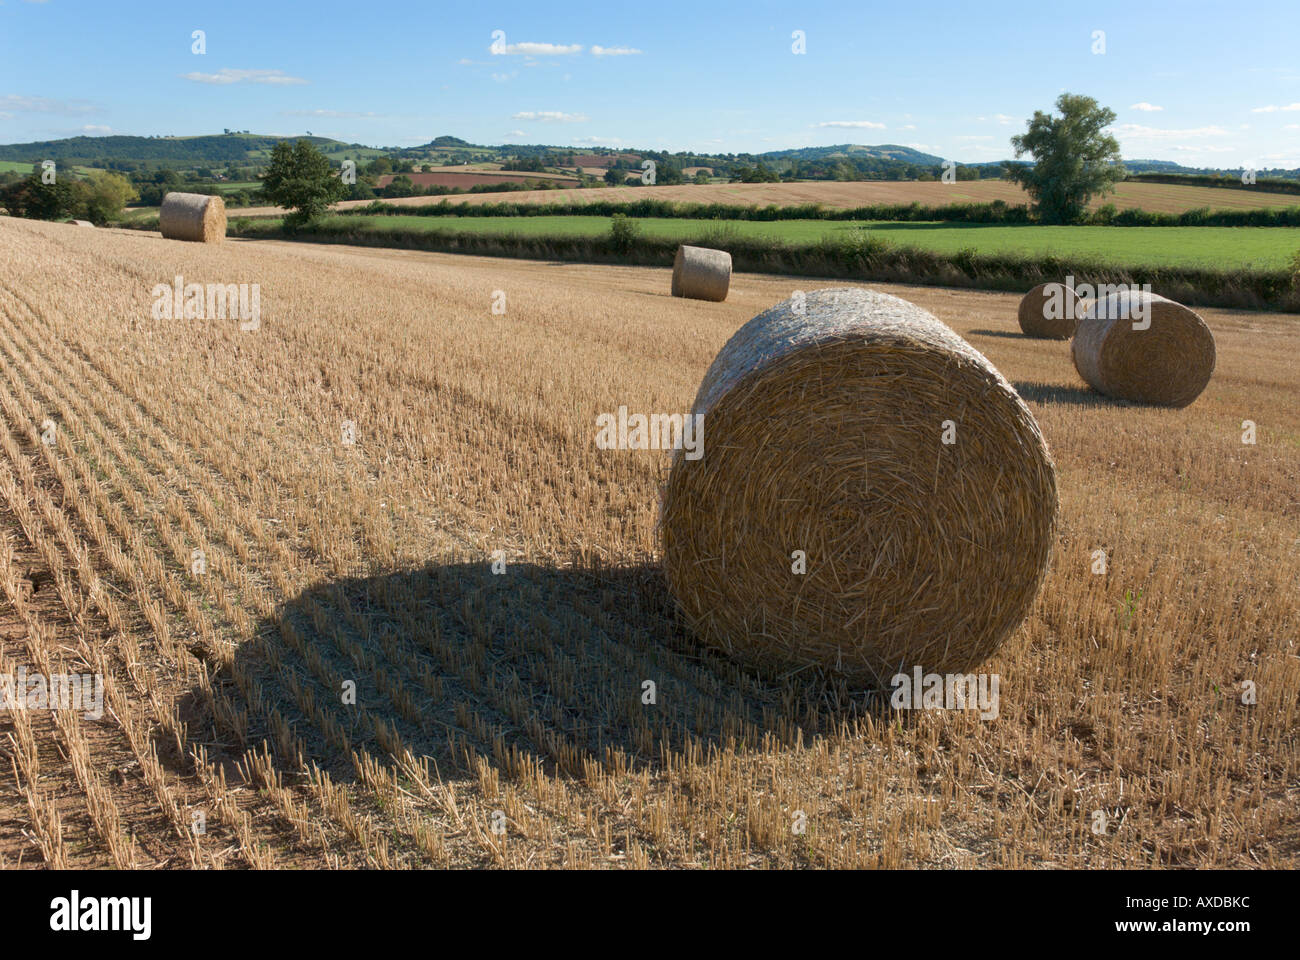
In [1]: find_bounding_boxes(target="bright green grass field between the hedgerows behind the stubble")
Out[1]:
[244,216,1300,269]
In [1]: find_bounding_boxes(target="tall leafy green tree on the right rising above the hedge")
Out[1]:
[1009,94,1125,224]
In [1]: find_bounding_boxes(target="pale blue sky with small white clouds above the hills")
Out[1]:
[0,0,1300,168]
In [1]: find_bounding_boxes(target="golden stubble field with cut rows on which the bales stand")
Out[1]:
[0,220,1300,868]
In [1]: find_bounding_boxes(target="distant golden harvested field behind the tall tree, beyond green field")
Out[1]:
[242,180,1300,216]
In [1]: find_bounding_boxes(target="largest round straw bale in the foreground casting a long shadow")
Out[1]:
[660,289,1057,687]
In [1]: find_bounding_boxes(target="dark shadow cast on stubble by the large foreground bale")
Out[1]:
[160,562,887,782]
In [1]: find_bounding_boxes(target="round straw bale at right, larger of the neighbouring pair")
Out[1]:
[1071,283,1216,407]
